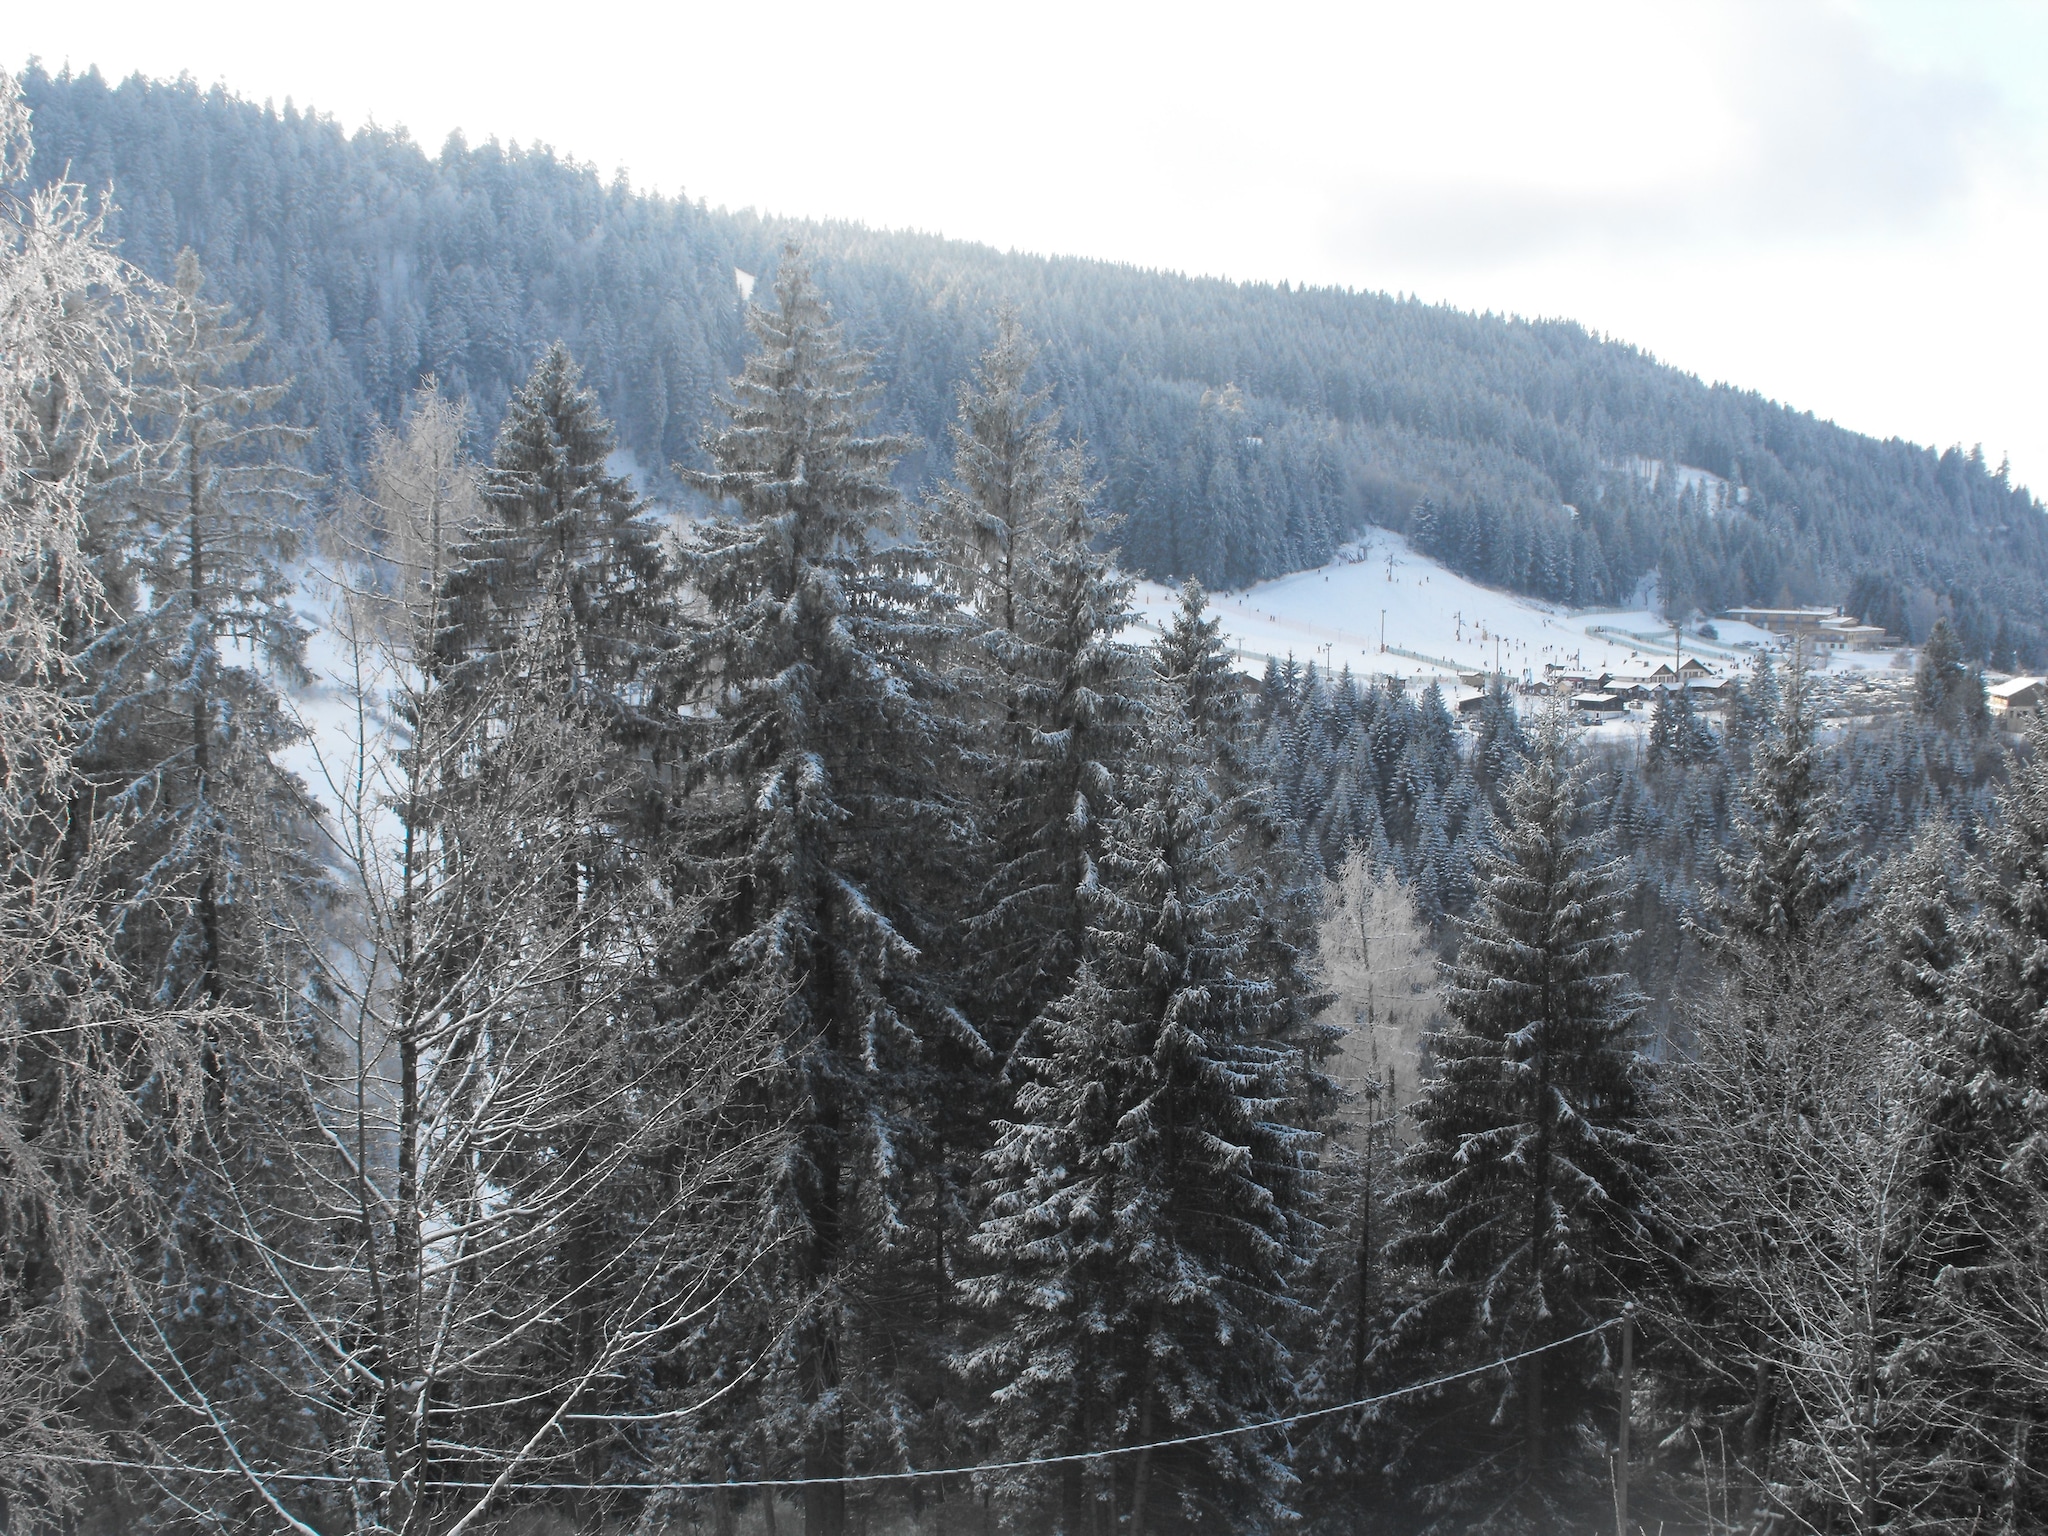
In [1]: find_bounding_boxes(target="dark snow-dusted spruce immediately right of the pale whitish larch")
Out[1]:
[1386,713,1653,1532]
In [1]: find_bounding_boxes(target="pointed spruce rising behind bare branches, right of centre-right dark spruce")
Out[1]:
[1659,668,1896,1518]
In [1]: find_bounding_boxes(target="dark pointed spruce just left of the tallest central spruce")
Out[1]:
[436,344,682,1479]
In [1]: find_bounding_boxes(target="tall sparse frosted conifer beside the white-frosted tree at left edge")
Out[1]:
[44,252,346,1518]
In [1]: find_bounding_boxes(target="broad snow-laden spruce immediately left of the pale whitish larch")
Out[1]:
[965,686,1315,1532]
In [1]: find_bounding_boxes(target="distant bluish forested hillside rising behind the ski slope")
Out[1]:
[25,70,2048,664]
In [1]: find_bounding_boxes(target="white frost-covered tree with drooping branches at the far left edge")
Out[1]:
[0,74,197,1530]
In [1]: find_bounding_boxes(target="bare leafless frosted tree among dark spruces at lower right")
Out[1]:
[1649,921,1925,1532]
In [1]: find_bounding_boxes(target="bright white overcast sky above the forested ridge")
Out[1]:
[16,0,2048,492]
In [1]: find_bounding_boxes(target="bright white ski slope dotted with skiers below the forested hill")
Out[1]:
[1137,528,1890,682]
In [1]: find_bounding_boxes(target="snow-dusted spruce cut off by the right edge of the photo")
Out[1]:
[1890,725,2048,1532]
